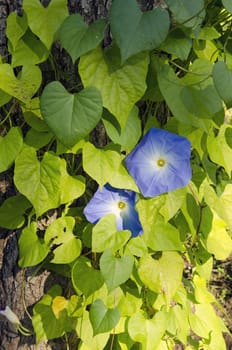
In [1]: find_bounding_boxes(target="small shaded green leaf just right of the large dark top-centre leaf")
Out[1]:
[160,29,192,60]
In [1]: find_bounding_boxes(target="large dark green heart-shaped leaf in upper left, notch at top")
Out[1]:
[41,81,102,147]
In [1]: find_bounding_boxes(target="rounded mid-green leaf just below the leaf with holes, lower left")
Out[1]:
[72,257,104,297]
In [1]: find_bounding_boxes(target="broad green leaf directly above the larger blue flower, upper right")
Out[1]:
[158,62,222,130]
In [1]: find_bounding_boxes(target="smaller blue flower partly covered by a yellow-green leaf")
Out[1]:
[84,185,142,237]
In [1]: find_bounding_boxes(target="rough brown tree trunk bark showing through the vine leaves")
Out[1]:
[0,0,162,350]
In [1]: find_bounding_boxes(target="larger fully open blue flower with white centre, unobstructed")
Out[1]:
[126,128,192,197]
